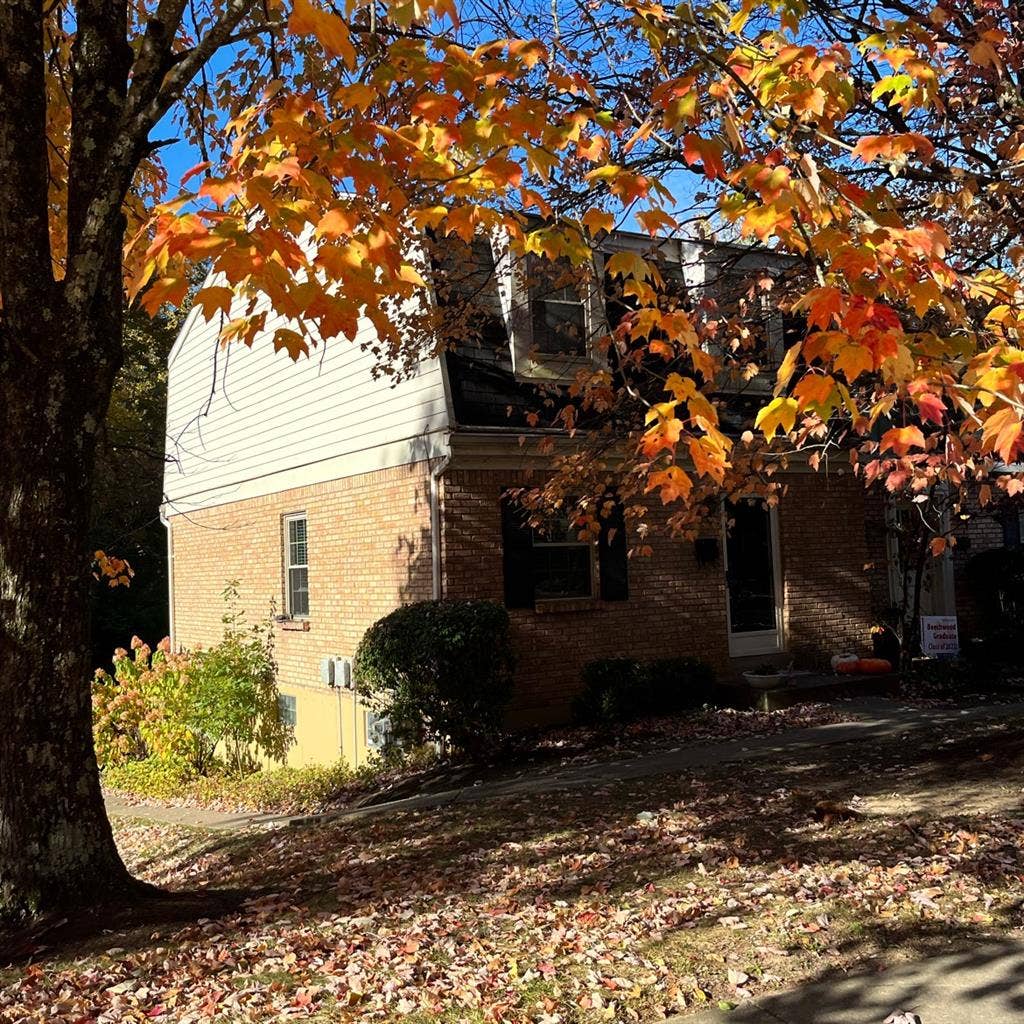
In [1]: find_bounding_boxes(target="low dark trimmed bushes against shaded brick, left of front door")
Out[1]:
[573,657,715,725]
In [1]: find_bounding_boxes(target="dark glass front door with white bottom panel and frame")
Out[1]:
[725,501,782,657]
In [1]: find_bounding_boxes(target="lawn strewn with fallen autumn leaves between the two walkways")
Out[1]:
[0,726,1024,1024]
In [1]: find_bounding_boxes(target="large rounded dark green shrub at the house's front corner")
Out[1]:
[355,601,513,758]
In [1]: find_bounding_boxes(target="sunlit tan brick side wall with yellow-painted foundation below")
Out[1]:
[171,462,431,763]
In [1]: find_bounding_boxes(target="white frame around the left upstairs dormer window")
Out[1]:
[490,232,607,383]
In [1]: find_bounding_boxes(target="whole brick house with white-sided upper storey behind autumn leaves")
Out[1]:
[164,233,872,763]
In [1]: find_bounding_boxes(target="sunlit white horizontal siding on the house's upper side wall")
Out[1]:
[164,288,449,515]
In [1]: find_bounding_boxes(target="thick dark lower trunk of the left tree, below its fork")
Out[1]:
[0,286,137,919]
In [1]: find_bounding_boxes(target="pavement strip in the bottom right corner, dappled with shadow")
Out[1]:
[674,939,1024,1024]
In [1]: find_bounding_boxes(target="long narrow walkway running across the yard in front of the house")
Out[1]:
[106,698,1024,835]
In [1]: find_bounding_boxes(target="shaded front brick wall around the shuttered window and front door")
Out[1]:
[443,469,870,719]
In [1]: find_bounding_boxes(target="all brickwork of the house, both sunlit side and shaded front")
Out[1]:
[172,463,870,745]
